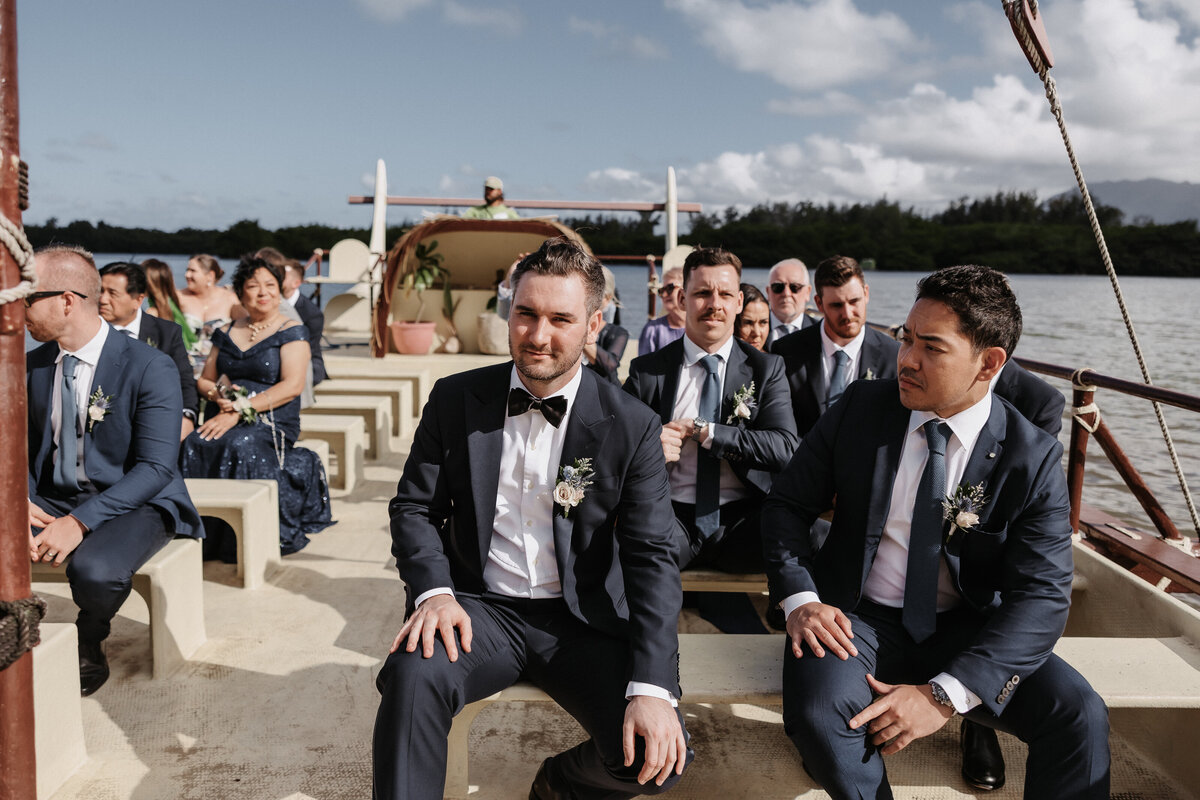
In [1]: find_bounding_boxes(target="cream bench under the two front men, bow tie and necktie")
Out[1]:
[445,633,1200,800]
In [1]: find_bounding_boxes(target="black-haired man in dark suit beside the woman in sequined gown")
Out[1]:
[100,261,200,441]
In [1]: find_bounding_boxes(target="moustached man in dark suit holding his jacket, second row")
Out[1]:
[625,247,797,572]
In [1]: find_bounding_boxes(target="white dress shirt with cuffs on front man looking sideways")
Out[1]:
[780,390,992,714]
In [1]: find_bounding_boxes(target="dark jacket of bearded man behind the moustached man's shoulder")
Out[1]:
[770,323,900,437]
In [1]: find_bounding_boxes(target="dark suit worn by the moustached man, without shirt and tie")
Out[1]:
[625,339,798,572]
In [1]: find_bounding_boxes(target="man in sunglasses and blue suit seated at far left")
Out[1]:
[25,246,203,696]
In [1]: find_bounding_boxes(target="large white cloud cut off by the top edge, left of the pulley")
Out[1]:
[666,0,925,91]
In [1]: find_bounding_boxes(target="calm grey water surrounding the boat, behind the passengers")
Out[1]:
[96,254,1200,533]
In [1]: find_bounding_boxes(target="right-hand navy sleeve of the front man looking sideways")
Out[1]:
[944,441,1074,714]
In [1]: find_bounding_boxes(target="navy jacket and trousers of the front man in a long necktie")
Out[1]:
[763,380,1108,798]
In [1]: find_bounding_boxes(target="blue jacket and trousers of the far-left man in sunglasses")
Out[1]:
[25,330,203,644]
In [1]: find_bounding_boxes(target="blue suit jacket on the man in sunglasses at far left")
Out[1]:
[25,331,204,537]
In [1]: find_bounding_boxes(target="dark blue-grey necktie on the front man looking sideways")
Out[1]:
[900,420,950,642]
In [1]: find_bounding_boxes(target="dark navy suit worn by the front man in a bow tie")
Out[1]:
[374,362,683,799]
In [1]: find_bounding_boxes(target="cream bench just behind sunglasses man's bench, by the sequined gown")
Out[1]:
[184,477,281,589]
